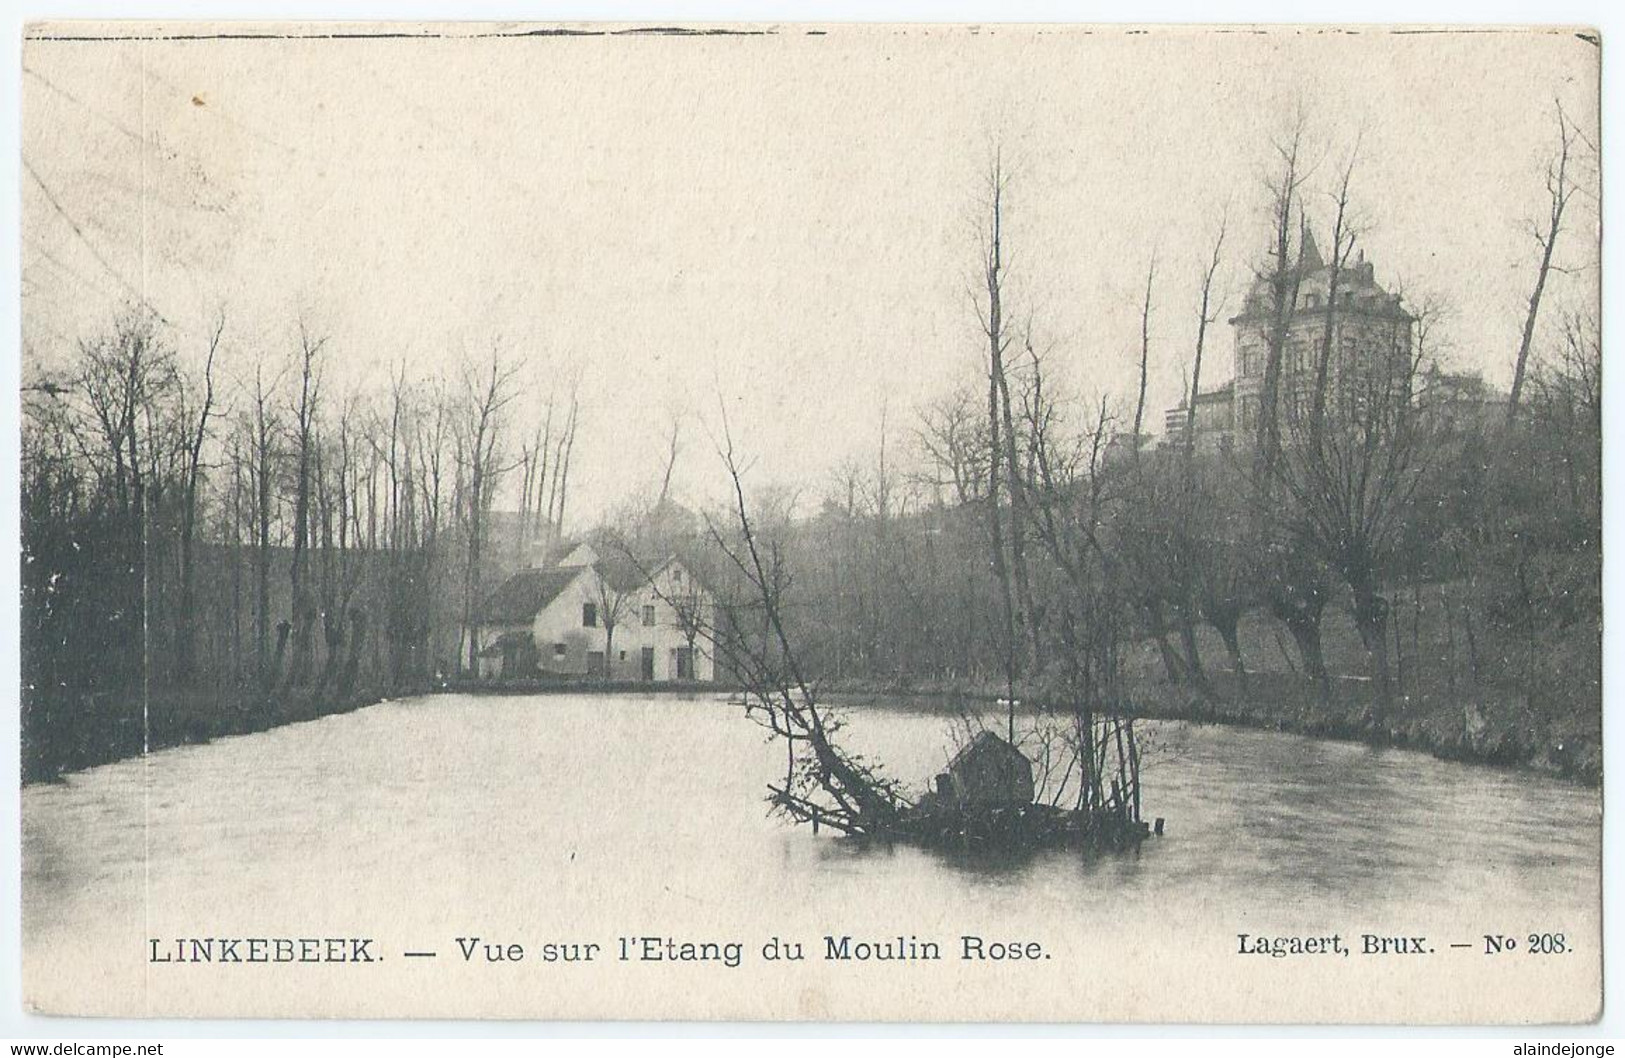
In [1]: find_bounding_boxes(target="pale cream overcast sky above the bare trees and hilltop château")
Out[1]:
[23,28,1597,518]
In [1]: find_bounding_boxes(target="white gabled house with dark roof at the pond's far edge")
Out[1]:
[478,544,717,683]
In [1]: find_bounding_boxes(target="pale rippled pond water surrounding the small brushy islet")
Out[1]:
[23,696,1601,1021]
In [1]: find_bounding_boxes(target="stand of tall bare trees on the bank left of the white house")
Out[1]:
[21,306,579,777]
